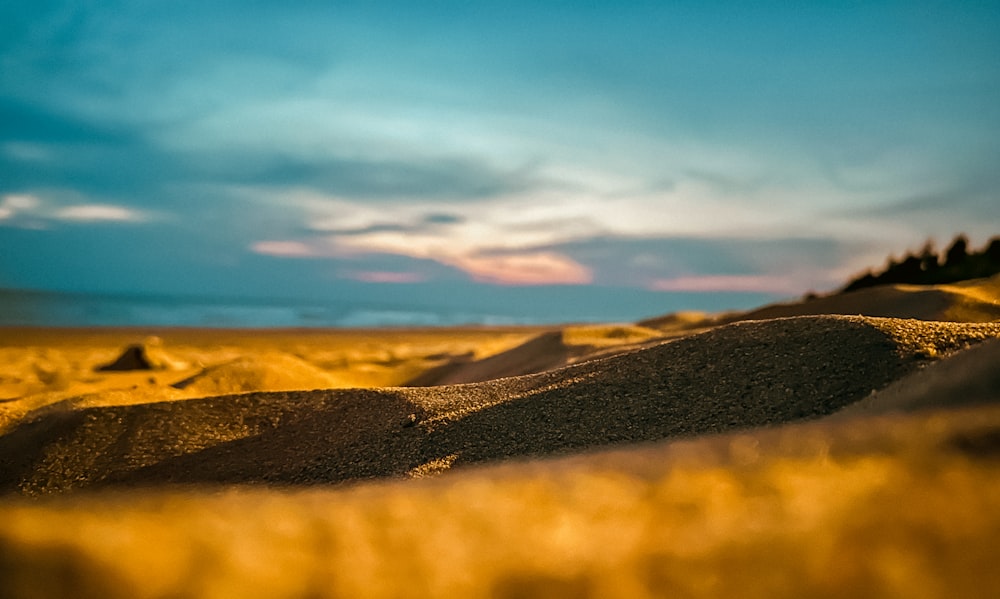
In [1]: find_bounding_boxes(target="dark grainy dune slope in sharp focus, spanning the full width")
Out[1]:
[0,316,1000,494]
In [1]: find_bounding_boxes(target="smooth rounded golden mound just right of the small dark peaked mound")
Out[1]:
[171,354,337,396]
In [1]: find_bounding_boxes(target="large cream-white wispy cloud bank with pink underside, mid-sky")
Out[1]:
[238,173,848,285]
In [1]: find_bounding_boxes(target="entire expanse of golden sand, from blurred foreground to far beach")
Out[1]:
[0,277,1000,598]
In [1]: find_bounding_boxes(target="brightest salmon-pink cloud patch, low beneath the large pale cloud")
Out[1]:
[449,252,593,285]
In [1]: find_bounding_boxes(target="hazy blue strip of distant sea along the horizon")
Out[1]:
[0,288,775,329]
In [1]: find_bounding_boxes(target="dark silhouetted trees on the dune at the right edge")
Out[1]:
[841,234,1000,292]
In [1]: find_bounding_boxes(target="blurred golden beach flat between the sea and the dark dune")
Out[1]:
[0,327,551,432]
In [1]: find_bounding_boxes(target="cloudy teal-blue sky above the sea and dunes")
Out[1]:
[0,0,1000,318]
